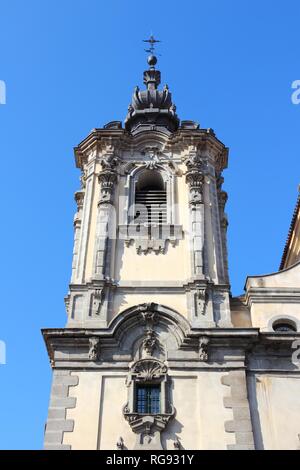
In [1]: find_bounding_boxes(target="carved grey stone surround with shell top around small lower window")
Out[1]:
[123,357,175,450]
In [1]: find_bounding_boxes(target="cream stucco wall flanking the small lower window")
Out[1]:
[63,371,235,450]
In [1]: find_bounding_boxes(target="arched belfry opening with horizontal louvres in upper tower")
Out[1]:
[134,170,167,225]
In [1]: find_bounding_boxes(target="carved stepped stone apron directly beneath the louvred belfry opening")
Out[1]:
[119,224,183,254]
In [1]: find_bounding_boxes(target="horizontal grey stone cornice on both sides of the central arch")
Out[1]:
[42,328,300,373]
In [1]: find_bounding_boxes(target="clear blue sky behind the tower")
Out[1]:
[0,0,300,449]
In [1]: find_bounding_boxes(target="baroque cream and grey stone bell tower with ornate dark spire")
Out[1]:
[43,45,300,450]
